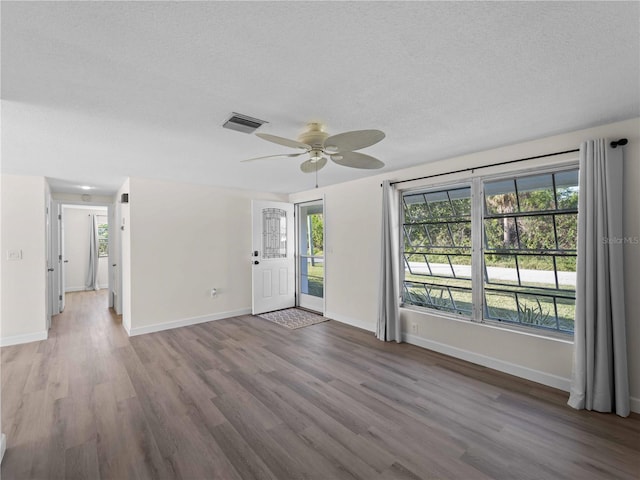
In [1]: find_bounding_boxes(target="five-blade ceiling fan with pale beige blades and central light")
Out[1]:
[242,123,385,173]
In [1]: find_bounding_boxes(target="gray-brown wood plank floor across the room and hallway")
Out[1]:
[2,291,640,480]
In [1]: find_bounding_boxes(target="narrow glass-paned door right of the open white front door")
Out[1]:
[296,200,325,314]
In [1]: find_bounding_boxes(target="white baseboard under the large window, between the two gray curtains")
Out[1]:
[402,333,571,392]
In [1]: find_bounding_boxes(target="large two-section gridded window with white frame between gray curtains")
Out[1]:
[402,167,578,334]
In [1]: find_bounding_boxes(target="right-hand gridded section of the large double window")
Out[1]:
[483,170,578,333]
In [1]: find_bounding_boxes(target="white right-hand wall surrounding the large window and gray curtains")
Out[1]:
[289,119,640,411]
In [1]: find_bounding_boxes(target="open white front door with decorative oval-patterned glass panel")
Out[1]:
[251,200,295,315]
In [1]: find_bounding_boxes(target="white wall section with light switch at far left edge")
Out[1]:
[0,174,47,345]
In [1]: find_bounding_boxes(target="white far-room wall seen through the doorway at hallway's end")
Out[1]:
[62,205,109,292]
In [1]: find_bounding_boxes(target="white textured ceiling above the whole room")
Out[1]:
[1,1,640,194]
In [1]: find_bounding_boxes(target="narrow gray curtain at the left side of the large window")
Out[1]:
[376,180,402,342]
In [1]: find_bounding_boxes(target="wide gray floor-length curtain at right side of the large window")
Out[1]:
[568,140,629,417]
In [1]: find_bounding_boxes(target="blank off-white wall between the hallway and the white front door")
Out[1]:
[123,178,286,335]
